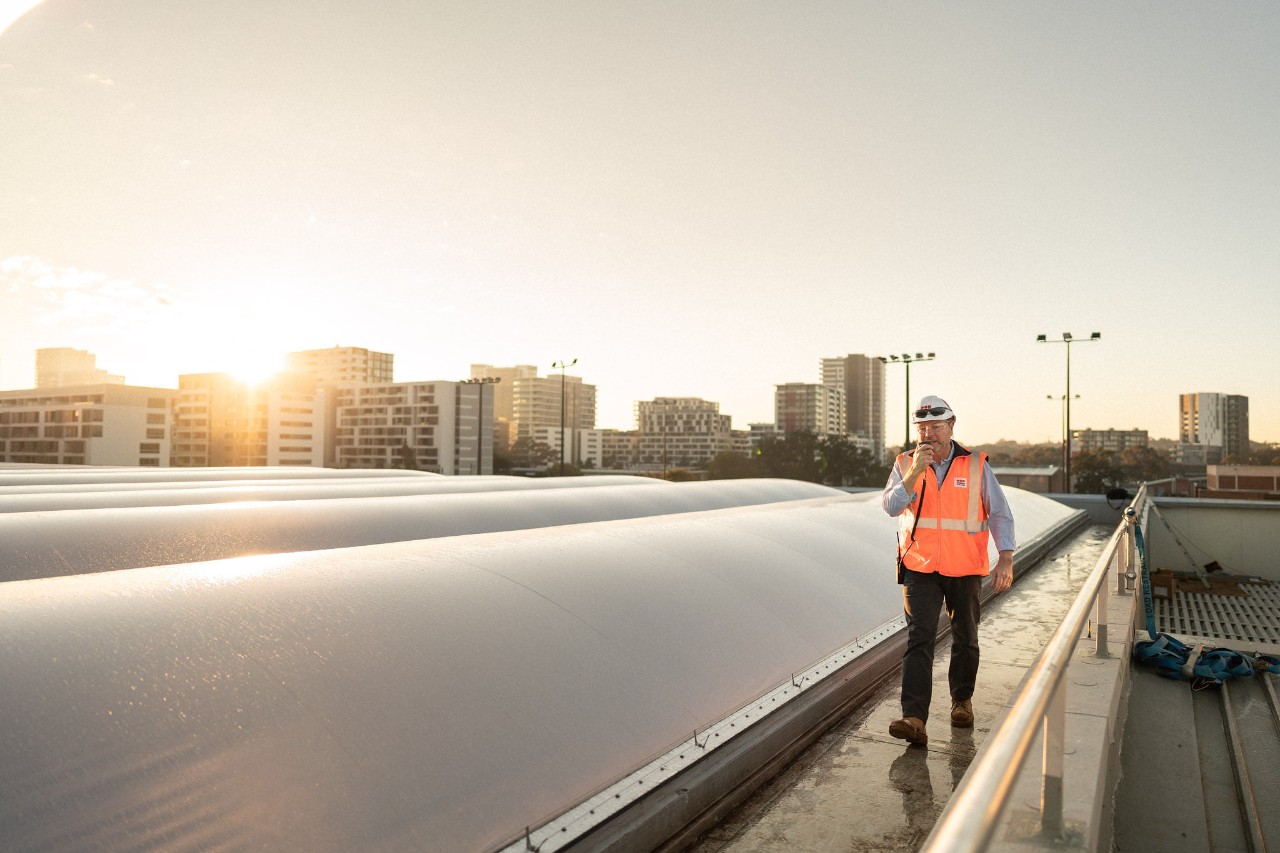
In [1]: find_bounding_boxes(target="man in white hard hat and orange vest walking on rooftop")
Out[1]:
[881,396,1014,745]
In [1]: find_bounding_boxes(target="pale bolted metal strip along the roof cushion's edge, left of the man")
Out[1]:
[502,616,906,853]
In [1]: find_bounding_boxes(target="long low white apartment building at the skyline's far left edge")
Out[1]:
[0,383,178,467]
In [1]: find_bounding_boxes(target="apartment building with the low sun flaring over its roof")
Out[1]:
[172,373,326,467]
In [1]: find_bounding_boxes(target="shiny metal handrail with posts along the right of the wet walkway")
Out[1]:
[920,484,1147,853]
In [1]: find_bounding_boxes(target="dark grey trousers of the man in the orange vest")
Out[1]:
[902,570,982,720]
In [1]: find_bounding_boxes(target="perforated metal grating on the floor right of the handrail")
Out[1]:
[1155,580,1280,646]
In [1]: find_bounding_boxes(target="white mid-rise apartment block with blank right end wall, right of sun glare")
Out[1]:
[334,380,500,474]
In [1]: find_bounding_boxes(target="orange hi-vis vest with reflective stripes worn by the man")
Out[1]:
[896,444,991,576]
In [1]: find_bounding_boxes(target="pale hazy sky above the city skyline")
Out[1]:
[0,0,1280,442]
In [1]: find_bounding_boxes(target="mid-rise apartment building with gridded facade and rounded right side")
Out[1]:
[636,397,733,470]
